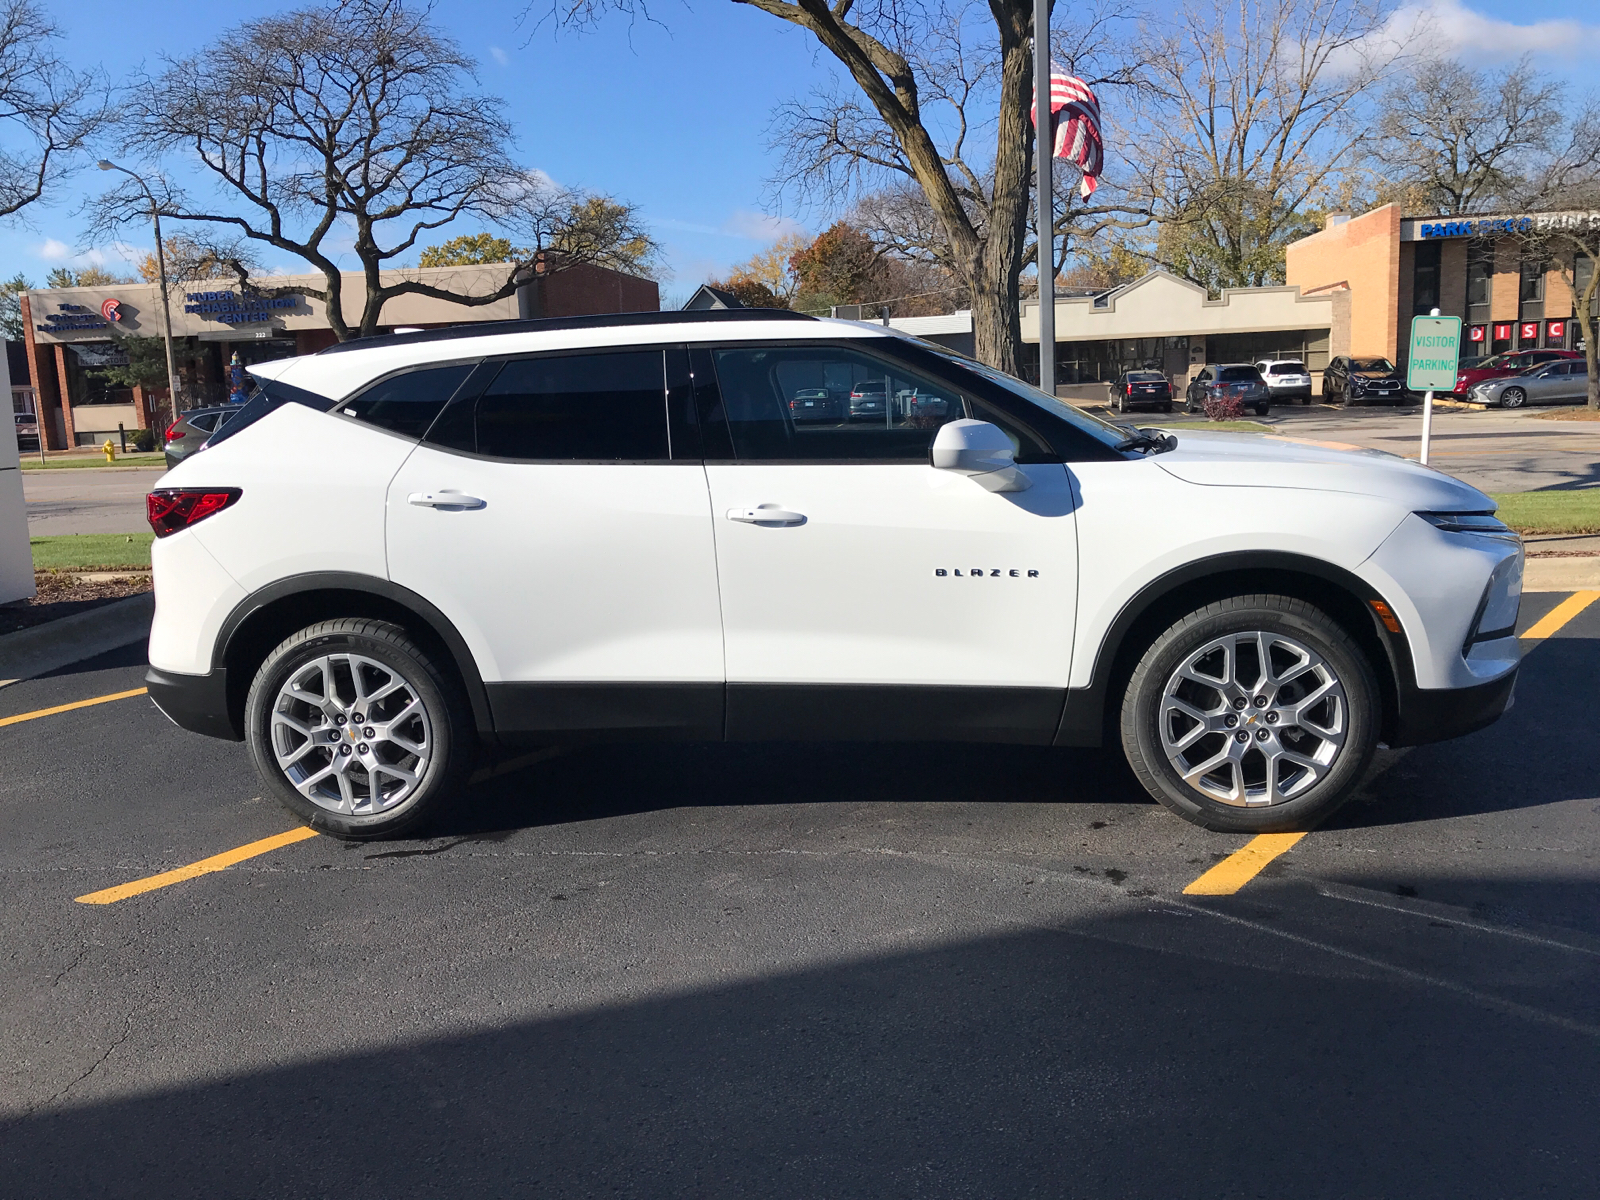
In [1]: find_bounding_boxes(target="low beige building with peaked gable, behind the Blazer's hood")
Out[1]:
[1017,270,1350,398]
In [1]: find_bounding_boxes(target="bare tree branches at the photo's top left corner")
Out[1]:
[0,0,107,216]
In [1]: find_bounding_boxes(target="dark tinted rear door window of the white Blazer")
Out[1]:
[475,350,670,462]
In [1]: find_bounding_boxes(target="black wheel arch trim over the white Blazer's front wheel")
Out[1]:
[1054,550,1418,746]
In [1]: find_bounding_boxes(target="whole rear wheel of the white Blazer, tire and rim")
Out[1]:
[245,618,474,840]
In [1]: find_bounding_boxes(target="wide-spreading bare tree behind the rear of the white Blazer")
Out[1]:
[91,0,653,341]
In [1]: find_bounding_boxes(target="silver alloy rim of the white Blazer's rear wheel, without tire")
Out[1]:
[270,654,434,816]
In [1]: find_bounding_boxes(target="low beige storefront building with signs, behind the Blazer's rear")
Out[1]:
[22,264,661,450]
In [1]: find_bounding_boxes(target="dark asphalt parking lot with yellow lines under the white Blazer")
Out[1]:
[0,594,1600,1197]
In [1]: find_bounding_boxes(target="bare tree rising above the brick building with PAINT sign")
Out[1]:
[1378,58,1565,216]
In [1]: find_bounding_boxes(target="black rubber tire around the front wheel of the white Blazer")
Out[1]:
[1122,595,1382,834]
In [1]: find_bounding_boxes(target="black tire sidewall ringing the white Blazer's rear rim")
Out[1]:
[245,622,467,840]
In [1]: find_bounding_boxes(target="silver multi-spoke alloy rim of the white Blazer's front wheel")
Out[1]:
[1157,630,1350,808]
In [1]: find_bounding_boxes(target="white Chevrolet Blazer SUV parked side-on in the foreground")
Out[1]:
[147,310,1522,838]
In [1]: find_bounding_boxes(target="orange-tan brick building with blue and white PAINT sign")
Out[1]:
[1286,205,1600,362]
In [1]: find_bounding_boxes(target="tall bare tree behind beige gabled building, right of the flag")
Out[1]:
[1120,0,1403,291]
